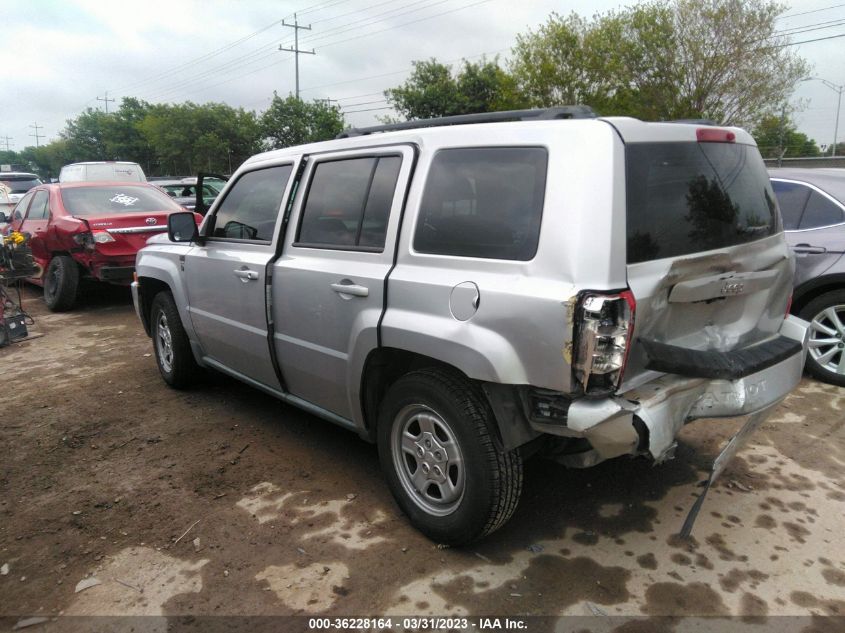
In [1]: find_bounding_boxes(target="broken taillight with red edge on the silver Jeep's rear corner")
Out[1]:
[573,290,637,393]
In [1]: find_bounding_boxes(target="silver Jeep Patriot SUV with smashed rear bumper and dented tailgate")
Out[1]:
[132,106,807,544]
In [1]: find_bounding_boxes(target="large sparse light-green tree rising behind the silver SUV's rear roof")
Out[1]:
[510,0,807,126]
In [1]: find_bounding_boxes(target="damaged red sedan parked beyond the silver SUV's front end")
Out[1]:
[11,182,202,312]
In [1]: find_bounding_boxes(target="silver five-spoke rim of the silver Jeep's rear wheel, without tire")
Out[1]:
[390,404,466,516]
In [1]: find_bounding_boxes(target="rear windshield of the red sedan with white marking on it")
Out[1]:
[62,186,184,215]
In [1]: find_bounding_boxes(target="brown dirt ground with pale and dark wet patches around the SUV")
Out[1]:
[0,288,845,631]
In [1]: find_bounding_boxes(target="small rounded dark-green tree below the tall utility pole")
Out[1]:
[260,92,344,149]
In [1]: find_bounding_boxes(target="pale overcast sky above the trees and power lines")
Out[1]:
[0,0,845,150]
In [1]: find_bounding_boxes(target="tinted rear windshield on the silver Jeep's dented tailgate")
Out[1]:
[626,143,779,264]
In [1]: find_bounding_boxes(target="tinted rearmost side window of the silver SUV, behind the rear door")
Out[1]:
[414,147,547,261]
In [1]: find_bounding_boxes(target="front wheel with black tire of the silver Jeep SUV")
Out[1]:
[150,290,199,389]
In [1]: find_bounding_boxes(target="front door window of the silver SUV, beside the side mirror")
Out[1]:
[209,165,293,242]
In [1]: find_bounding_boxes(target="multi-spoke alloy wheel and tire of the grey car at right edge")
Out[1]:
[798,289,845,387]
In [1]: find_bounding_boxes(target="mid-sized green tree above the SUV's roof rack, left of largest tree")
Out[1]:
[384,59,527,119]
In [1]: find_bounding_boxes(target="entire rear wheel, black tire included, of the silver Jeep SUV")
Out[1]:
[378,369,522,545]
